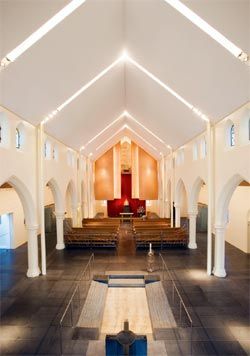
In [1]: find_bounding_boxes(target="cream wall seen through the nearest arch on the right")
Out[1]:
[226,186,250,253]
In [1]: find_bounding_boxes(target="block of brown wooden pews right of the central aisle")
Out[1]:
[133,218,188,249]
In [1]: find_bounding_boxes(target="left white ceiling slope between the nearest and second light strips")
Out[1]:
[1,0,122,124]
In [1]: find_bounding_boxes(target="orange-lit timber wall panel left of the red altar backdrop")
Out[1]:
[95,148,114,200]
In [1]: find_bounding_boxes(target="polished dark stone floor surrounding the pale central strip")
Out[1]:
[0,232,250,356]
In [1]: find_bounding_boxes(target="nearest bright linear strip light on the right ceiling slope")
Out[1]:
[164,0,249,62]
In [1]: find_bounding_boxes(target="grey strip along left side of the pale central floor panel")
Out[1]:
[77,281,108,329]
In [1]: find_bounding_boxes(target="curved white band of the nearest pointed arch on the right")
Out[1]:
[216,174,247,225]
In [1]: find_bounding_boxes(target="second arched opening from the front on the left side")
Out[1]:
[44,179,64,250]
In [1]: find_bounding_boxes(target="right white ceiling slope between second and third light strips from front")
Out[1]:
[126,65,205,147]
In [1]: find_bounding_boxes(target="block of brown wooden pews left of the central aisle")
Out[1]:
[64,218,120,248]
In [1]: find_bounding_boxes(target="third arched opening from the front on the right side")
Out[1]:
[174,179,188,227]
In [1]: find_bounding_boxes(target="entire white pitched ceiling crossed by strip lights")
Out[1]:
[0,0,250,155]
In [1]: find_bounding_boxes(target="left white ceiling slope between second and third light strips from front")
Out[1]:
[45,63,124,149]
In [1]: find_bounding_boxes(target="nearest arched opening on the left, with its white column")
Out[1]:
[0,176,40,277]
